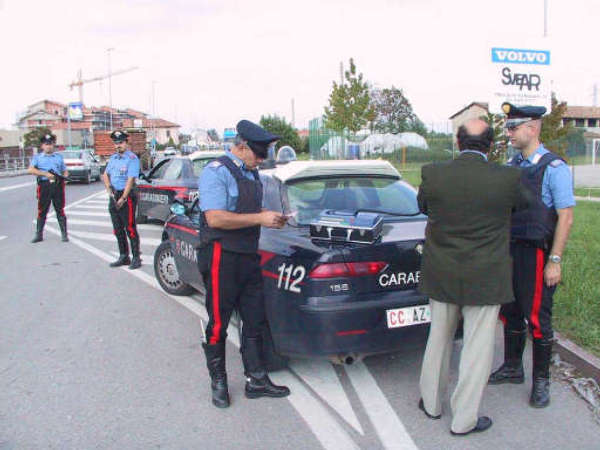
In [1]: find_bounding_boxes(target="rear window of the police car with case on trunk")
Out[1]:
[286,176,419,225]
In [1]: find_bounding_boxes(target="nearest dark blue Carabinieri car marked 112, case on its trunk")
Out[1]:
[154,155,430,363]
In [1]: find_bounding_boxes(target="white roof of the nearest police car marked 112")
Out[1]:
[261,159,401,183]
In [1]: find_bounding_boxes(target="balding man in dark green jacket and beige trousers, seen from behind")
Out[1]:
[418,119,527,435]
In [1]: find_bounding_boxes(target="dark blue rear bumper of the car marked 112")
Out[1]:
[271,290,429,357]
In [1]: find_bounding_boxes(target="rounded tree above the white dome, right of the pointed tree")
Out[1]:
[371,86,426,135]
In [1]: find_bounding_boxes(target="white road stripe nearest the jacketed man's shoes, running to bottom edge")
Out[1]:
[345,361,417,450]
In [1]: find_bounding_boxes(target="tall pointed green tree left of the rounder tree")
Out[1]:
[325,58,375,133]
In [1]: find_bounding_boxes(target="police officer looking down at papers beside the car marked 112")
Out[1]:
[198,120,290,408]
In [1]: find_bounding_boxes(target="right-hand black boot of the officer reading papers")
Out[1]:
[240,336,290,398]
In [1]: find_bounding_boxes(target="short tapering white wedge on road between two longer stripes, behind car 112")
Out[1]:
[290,359,364,434]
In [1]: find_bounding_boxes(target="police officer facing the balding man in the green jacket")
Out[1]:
[489,103,575,408]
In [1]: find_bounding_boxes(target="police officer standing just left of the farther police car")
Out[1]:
[102,130,142,270]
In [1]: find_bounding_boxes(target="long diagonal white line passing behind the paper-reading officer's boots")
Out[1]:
[46,226,359,450]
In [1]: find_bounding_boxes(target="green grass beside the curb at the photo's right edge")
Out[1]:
[554,201,600,356]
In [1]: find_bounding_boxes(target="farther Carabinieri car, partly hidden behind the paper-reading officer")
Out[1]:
[136,151,224,223]
